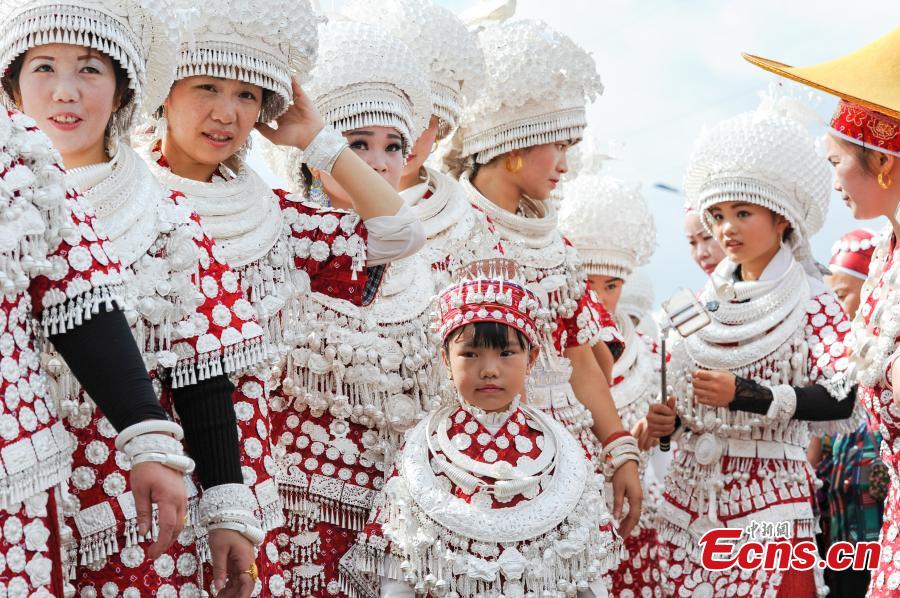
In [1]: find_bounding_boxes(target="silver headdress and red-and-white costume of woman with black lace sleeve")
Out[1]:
[659,88,850,596]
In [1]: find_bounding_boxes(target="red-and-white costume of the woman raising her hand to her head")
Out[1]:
[143,137,380,595]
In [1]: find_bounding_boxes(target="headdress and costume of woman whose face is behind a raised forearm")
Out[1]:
[256,22,438,596]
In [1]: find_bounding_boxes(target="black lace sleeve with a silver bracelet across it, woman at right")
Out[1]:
[728,377,856,421]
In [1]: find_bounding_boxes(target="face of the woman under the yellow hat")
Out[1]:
[827,135,896,220]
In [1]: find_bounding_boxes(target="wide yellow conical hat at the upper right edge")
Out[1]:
[743,27,900,118]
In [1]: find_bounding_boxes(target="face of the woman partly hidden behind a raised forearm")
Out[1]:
[319,127,404,209]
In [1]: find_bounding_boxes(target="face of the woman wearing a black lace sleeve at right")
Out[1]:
[709,201,788,267]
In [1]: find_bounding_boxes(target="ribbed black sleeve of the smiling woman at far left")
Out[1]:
[172,374,244,488]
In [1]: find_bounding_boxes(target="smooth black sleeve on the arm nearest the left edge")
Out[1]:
[50,309,168,432]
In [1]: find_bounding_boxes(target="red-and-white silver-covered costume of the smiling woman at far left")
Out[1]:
[50,143,268,596]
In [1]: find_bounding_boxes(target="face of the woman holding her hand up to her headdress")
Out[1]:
[163,76,263,172]
